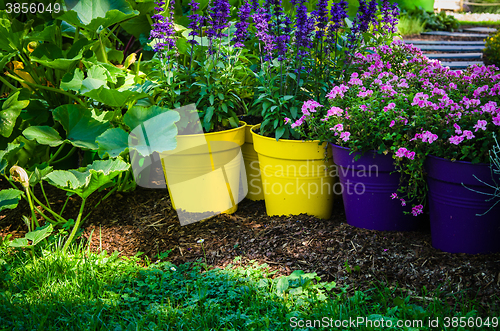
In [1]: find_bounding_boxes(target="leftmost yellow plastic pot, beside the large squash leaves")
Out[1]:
[160,122,246,223]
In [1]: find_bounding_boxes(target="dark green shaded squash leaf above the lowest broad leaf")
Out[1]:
[52,105,110,149]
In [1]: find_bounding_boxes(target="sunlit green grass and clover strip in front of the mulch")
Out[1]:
[0,241,499,330]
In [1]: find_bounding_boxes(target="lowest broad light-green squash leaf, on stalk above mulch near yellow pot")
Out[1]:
[43,159,130,199]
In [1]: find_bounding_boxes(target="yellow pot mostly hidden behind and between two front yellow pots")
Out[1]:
[241,125,264,201]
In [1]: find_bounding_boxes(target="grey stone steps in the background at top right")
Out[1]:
[405,27,496,69]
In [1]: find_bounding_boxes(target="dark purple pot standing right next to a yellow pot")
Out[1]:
[331,144,421,231]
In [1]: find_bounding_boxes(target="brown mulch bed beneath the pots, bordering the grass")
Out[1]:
[0,174,500,313]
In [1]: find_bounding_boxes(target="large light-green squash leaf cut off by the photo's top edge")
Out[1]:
[60,0,139,32]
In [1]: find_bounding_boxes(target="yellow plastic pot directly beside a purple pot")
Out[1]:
[251,124,334,219]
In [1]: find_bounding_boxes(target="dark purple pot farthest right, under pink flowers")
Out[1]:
[425,156,500,254]
